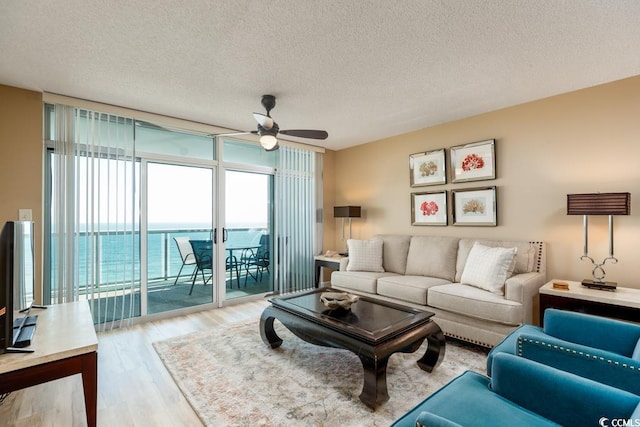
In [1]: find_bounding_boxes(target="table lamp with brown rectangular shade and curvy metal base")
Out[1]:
[567,193,631,290]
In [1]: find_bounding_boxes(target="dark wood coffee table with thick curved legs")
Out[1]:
[260,288,445,409]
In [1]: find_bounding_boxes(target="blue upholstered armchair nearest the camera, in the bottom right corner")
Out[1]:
[393,353,640,427]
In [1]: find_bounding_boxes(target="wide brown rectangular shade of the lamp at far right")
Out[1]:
[567,193,631,215]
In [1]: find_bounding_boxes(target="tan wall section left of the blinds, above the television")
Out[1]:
[0,85,42,302]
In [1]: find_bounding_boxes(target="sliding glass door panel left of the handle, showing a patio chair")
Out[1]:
[143,162,217,314]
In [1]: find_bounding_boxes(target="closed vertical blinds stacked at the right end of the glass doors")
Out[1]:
[276,146,319,293]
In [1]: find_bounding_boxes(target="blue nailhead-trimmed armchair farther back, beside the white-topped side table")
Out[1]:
[487,309,640,395]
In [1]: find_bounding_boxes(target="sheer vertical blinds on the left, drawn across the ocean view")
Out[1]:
[51,105,140,329]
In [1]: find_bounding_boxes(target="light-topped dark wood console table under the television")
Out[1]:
[0,301,98,427]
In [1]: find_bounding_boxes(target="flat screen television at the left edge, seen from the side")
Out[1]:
[0,221,37,353]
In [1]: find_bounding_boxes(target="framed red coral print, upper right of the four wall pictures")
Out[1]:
[449,139,496,183]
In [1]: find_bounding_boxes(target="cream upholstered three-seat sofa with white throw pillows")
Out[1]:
[331,235,546,347]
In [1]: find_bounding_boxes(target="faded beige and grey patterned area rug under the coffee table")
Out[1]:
[154,320,486,426]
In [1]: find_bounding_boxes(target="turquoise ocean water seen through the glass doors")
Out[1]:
[51,226,267,289]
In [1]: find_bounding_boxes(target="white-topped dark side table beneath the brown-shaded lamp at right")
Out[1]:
[540,280,640,324]
